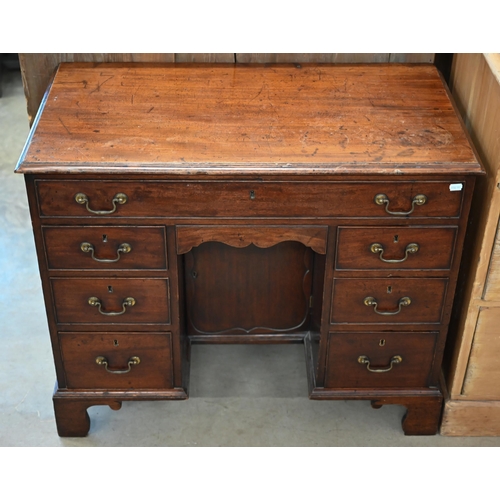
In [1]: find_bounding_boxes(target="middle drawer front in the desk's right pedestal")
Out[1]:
[331,278,448,324]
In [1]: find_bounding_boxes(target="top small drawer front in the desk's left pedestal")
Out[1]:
[42,226,167,271]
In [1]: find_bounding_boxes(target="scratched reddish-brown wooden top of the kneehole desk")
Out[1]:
[17,64,481,175]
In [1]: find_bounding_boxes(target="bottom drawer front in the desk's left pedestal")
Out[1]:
[59,333,173,389]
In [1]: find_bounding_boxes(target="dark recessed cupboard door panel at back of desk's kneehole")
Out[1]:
[185,242,312,335]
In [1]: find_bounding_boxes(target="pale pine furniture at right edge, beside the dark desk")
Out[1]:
[441,54,500,436]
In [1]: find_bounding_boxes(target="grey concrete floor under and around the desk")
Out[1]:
[0,64,500,447]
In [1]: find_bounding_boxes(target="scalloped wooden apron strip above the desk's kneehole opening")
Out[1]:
[176,225,328,254]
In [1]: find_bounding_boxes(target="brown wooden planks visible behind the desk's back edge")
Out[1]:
[19,53,434,123]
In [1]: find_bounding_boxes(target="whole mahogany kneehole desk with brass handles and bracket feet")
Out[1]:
[17,64,482,436]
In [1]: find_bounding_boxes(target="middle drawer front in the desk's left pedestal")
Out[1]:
[51,278,170,324]
